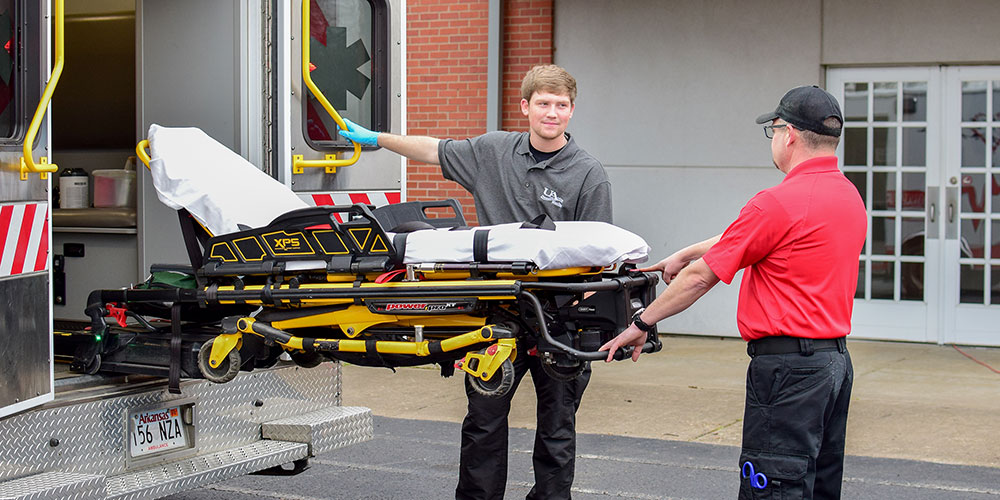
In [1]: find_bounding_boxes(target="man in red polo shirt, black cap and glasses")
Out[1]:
[601,86,867,499]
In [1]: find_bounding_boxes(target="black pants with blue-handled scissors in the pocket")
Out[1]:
[739,349,854,500]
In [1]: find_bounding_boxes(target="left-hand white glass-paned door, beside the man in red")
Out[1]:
[827,68,941,341]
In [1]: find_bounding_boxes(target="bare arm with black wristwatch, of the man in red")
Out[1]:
[599,258,719,362]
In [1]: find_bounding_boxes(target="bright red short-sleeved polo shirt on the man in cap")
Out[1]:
[704,156,868,340]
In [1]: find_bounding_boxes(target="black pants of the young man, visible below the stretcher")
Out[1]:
[455,352,590,500]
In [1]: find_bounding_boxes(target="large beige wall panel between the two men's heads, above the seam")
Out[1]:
[555,0,821,167]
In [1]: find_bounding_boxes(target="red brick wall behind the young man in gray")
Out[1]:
[406,0,553,224]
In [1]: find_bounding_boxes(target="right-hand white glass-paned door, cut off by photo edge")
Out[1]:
[942,66,1000,345]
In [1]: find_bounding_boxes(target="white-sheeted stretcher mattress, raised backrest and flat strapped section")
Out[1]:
[148,124,649,269]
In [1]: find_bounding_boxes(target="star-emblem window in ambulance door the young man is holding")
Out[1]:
[306,0,373,141]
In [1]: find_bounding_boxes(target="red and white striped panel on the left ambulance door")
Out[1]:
[0,203,49,276]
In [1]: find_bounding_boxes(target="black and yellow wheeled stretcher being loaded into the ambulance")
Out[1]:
[74,129,661,396]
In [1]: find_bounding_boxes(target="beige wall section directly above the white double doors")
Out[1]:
[822,0,1000,66]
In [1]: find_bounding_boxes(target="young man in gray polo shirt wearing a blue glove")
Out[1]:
[341,65,611,500]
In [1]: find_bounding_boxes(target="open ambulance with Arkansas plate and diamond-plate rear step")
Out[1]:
[0,0,405,499]
